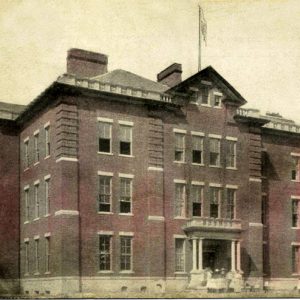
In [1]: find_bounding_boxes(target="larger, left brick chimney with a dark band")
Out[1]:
[67,48,108,77]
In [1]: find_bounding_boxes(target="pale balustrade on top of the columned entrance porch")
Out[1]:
[184,217,242,230]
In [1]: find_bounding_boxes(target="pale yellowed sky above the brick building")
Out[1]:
[0,0,300,123]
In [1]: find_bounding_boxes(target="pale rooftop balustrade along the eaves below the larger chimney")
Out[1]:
[57,74,172,103]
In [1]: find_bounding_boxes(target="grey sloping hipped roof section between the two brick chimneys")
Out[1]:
[91,69,169,93]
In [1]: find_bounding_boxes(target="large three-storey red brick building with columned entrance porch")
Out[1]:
[0,49,300,295]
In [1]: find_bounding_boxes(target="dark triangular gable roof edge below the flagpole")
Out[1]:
[169,66,247,105]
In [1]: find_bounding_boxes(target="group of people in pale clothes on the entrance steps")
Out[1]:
[205,268,243,293]
